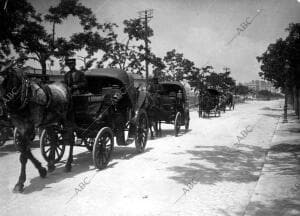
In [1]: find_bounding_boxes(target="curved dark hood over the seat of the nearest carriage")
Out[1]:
[85,68,136,105]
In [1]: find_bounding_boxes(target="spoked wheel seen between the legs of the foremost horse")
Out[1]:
[40,126,65,163]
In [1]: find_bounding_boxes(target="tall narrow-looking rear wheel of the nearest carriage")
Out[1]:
[135,109,149,153]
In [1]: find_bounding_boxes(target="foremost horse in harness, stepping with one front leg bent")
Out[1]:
[0,64,74,192]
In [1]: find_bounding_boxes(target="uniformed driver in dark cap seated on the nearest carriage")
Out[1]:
[64,59,87,95]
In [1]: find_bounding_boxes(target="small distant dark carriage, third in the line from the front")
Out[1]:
[198,88,221,117]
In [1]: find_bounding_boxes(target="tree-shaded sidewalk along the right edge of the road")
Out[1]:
[245,110,300,216]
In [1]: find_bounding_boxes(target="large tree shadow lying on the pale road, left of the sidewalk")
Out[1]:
[168,144,265,185]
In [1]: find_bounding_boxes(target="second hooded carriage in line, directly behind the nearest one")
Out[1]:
[148,82,190,136]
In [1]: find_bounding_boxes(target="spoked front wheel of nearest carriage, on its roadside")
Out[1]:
[93,127,114,170]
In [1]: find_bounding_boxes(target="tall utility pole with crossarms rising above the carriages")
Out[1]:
[138,9,153,88]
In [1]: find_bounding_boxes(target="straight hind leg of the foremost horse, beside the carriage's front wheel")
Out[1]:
[63,122,74,172]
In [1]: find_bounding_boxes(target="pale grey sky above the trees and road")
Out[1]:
[29,0,300,82]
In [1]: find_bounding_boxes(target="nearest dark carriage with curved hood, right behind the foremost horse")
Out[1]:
[40,69,148,169]
